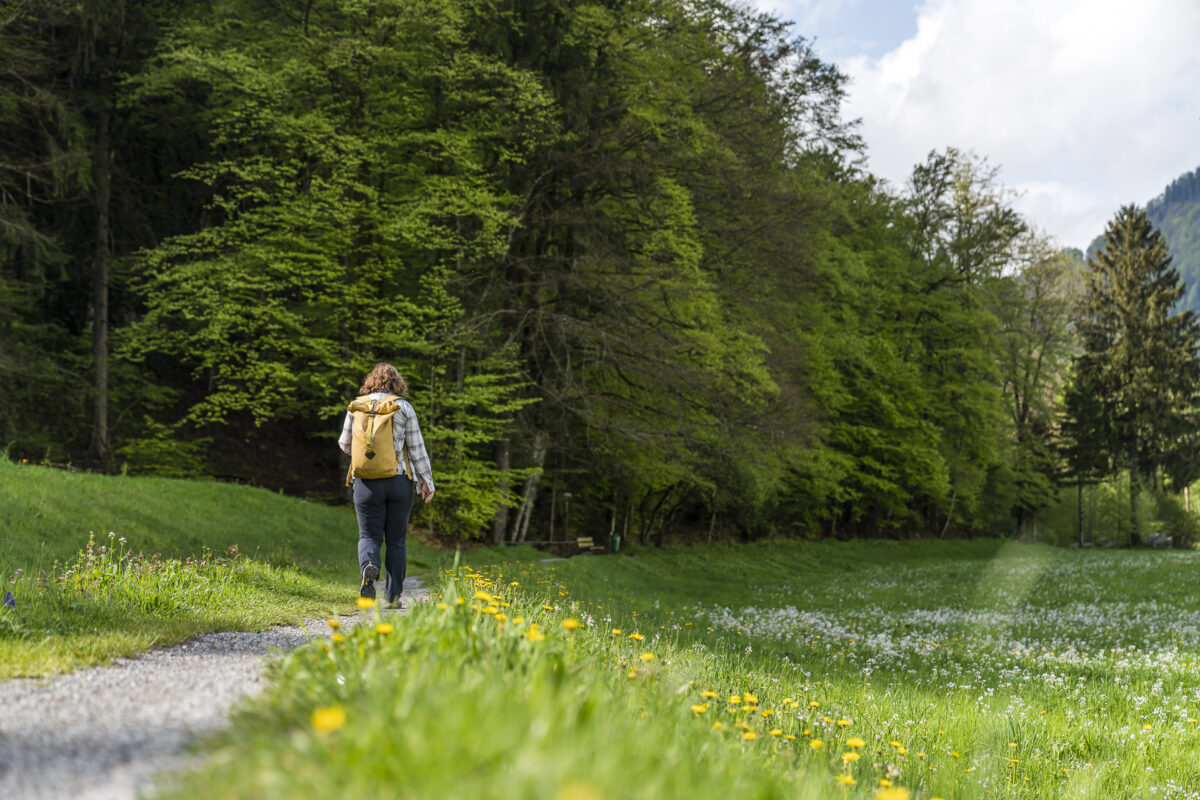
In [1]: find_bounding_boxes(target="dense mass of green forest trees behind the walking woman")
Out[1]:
[0,0,1132,543]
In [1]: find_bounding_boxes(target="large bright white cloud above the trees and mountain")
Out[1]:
[840,0,1200,247]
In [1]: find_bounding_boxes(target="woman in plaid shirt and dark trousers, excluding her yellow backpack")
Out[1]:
[337,363,433,608]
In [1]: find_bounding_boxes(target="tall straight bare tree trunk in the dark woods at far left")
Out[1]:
[90,107,113,468]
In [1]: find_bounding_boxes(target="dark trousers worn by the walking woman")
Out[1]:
[354,475,416,602]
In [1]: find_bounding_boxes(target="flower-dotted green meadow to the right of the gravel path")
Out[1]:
[162,541,1200,800]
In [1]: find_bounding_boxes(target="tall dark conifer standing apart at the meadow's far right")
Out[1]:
[1076,206,1200,545]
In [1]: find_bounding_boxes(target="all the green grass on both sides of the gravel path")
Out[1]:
[7,463,1200,800]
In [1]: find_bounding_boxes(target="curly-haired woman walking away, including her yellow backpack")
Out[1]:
[337,363,433,608]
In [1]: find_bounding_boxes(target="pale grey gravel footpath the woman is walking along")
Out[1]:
[0,578,428,800]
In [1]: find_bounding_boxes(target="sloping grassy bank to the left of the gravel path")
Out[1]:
[0,459,430,679]
